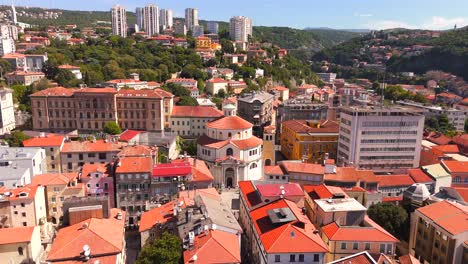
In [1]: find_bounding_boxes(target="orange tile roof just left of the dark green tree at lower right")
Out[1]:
[322,216,398,243]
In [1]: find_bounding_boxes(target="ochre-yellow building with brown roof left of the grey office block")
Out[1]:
[280,120,339,163]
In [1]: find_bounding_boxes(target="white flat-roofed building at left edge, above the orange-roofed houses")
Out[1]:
[0,148,47,180]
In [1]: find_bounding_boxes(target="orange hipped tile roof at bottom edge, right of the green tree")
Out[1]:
[184,230,241,263]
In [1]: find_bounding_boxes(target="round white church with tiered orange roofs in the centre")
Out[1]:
[197,110,263,187]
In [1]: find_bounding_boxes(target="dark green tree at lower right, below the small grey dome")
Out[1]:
[367,202,408,237]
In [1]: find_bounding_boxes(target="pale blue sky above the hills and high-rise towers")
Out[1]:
[11,0,468,29]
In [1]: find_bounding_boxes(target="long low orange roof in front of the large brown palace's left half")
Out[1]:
[61,140,127,153]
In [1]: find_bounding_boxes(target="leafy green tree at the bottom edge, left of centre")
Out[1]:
[136,232,182,264]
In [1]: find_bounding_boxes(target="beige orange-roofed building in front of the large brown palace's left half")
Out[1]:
[60,140,127,172]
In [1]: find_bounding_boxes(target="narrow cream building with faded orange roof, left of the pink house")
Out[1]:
[31,172,85,224]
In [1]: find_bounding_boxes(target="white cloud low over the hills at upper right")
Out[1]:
[364,16,468,30]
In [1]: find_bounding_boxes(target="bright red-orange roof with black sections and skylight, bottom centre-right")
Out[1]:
[250,199,328,254]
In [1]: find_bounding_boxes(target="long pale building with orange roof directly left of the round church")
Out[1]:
[170,106,224,138]
